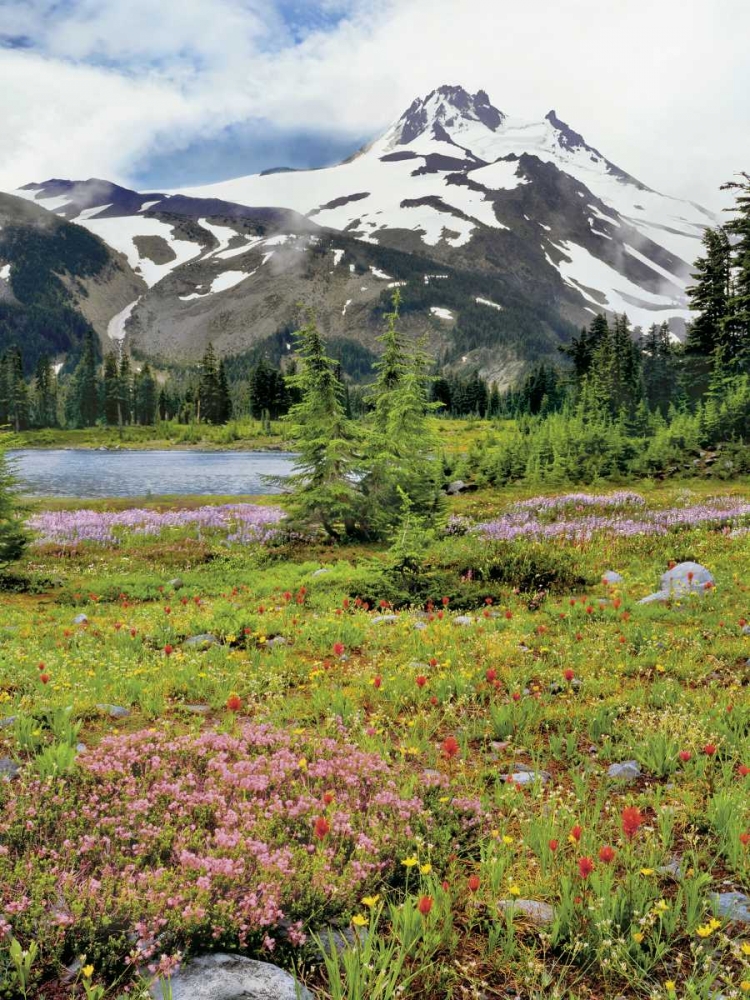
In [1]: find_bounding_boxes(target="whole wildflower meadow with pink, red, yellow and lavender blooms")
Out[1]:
[0,482,750,1000]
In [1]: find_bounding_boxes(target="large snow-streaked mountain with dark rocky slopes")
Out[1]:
[10,87,716,383]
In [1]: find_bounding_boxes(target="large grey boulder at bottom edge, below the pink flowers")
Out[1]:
[151,953,313,1000]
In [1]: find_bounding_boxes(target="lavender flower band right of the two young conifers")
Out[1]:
[472,493,750,541]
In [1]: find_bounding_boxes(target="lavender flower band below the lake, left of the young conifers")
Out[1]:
[28,503,284,546]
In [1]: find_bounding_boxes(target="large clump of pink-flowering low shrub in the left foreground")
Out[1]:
[0,724,425,988]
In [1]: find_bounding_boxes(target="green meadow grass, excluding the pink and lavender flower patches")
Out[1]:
[0,480,750,1000]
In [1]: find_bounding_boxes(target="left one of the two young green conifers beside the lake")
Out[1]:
[285,313,362,539]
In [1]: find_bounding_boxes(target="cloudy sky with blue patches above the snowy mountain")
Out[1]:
[0,0,750,209]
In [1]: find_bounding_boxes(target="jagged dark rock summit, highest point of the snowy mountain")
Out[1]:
[393,84,505,146]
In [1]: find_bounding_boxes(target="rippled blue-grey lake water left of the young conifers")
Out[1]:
[8,448,294,499]
